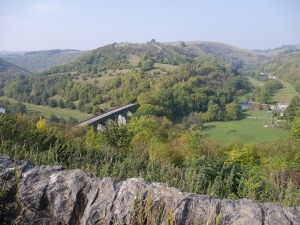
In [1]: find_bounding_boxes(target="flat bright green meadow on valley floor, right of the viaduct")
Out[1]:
[200,110,289,144]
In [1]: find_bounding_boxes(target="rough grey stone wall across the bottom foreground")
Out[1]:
[0,155,300,225]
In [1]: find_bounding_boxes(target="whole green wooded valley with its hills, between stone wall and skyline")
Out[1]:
[0,40,300,210]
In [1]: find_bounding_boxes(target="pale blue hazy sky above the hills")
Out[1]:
[0,0,300,51]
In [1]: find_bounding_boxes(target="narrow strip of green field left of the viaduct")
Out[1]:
[0,96,93,121]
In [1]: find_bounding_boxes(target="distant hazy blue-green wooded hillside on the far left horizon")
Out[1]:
[1,49,87,73]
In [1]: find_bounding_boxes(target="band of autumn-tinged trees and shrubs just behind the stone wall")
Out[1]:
[0,110,300,206]
